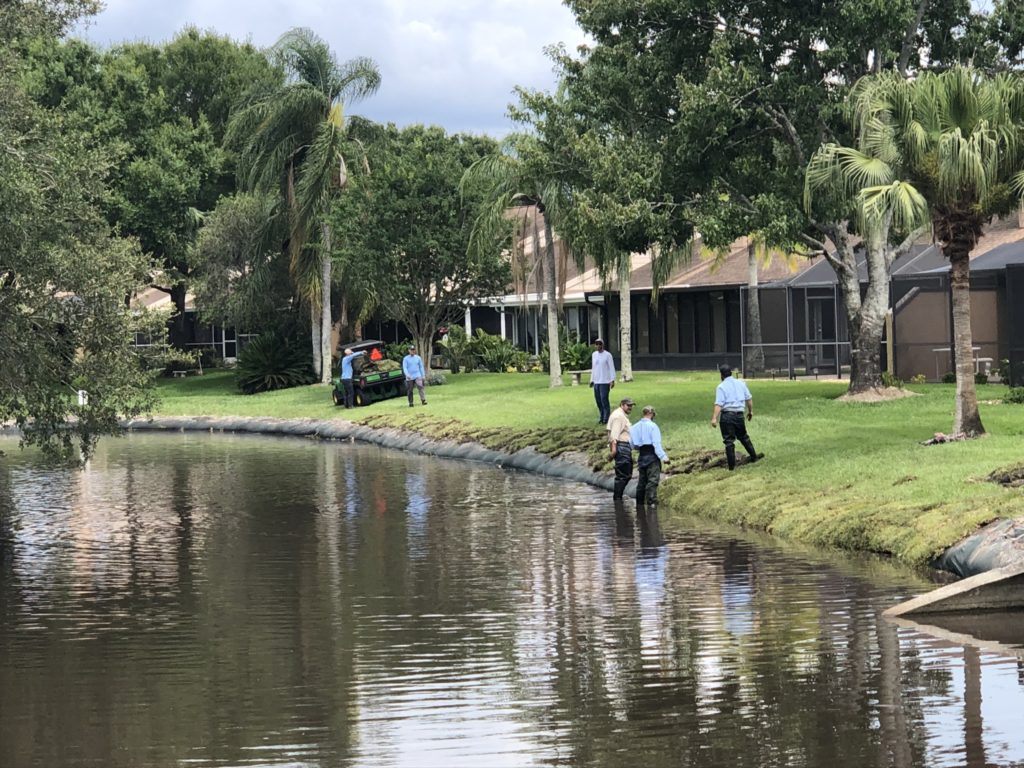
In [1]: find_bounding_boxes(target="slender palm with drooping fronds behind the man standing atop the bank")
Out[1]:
[463,134,565,387]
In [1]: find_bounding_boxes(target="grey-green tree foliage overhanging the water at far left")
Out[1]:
[0,2,162,457]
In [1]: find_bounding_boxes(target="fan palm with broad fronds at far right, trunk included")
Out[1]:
[808,68,1024,437]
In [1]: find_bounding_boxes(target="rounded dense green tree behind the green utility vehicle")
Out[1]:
[332,125,510,370]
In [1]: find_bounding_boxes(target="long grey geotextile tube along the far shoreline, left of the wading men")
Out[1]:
[122,417,636,497]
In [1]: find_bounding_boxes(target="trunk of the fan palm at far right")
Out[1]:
[947,249,985,437]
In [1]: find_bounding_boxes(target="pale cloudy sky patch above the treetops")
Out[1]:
[78,0,584,136]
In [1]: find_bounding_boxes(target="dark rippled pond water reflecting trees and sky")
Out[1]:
[0,434,1024,768]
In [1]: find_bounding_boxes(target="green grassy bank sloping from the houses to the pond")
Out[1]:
[151,372,1024,563]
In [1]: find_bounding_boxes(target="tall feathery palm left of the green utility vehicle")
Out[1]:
[226,28,381,384]
